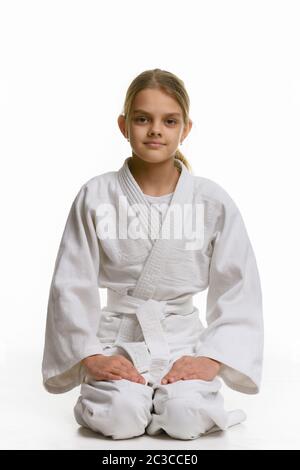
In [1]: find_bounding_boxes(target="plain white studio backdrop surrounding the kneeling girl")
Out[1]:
[0,0,300,449]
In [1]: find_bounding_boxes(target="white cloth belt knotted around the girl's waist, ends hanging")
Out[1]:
[107,289,194,378]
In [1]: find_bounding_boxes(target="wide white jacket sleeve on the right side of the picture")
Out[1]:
[196,193,264,394]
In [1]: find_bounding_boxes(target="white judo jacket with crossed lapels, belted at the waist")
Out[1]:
[42,157,264,394]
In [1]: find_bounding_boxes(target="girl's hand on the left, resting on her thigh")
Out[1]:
[81,354,146,384]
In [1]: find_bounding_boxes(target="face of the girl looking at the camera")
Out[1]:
[122,89,192,163]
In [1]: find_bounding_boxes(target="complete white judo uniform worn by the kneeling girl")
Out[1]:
[42,157,263,439]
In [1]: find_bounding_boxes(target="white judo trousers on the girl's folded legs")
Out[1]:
[74,374,246,439]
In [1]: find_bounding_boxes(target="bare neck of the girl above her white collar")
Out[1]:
[128,155,180,196]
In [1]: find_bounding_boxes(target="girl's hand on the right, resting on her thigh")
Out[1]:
[161,356,221,385]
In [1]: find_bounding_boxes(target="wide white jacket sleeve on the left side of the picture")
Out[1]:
[42,185,103,393]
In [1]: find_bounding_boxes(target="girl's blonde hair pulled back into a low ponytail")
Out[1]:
[123,69,192,171]
